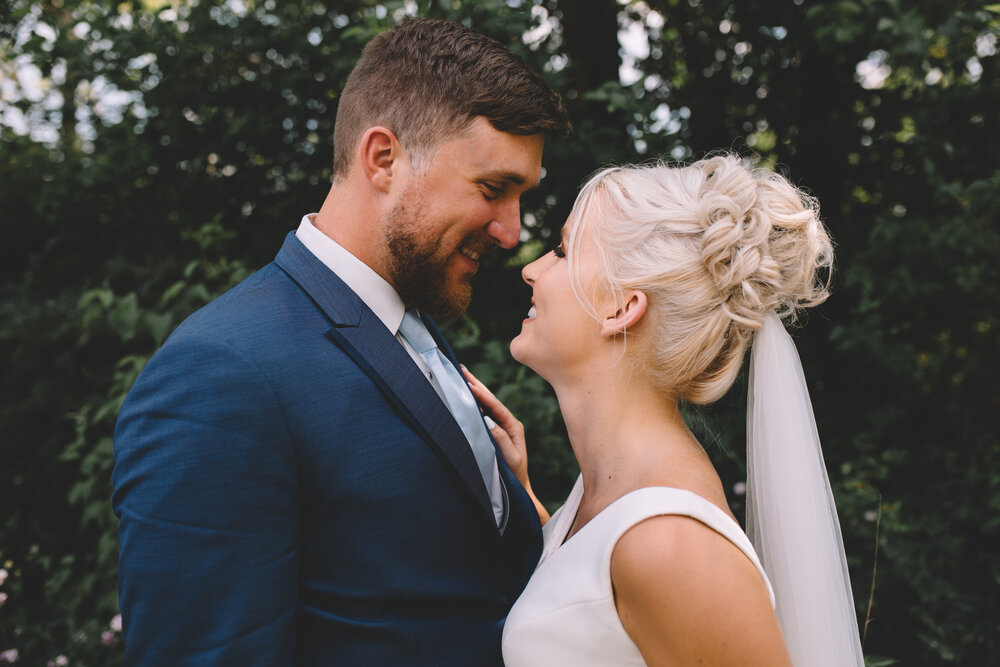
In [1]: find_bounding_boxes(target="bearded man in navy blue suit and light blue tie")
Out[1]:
[113,19,569,666]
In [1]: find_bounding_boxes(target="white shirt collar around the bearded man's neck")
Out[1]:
[295,213,406,336]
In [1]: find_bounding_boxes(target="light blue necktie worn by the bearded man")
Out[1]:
[399,310,496,508]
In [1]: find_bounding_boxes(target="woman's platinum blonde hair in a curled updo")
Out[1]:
[567,155,833,404]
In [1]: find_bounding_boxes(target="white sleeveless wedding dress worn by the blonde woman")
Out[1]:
[503,478,774,667]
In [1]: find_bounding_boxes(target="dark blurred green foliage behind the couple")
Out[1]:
[0,0,1000,667]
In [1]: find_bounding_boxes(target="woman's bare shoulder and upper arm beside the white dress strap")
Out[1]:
[611,515,791,666]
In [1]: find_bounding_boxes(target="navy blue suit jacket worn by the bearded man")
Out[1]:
[113,233,541,667]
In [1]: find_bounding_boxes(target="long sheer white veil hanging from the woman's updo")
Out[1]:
[746,312,864,667]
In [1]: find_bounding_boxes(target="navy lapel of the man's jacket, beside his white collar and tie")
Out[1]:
[275,232,494,523]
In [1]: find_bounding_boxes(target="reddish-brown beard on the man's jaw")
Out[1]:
[385,190,472,317]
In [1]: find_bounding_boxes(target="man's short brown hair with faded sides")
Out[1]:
[333,19,570,178]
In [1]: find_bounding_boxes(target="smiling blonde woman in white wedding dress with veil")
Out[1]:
[469,155,863,667]
